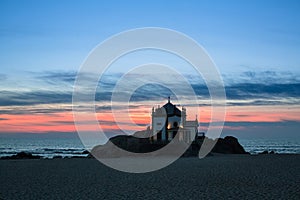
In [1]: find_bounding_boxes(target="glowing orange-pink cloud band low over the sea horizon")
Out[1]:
[0,106,300,133]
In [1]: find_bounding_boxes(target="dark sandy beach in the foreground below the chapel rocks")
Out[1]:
[0,155,300,200]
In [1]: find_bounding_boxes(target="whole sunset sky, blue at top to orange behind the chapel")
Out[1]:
[0,0,300,138]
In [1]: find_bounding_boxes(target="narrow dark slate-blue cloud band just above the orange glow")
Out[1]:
[0,80,300,109]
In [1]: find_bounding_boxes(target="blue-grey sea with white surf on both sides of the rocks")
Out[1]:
[0,134,300,158]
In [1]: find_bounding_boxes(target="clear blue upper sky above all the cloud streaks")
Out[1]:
[0,1,300,72]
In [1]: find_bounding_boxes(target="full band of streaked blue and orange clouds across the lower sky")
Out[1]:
[0,71,300,135]
